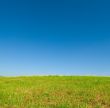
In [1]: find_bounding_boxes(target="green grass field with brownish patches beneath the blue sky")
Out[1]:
[0,76,110,108]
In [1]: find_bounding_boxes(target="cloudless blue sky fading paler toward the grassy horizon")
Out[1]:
[0,0,110,76]
